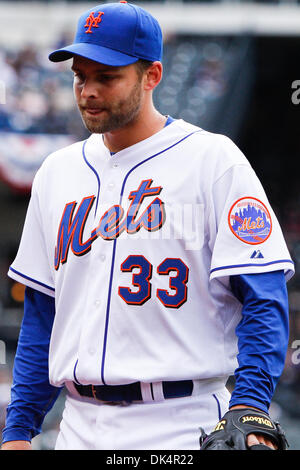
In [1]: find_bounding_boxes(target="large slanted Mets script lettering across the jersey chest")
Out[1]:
[54,179,166,270]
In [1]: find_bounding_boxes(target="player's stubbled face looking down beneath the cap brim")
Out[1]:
[72,57,143,134]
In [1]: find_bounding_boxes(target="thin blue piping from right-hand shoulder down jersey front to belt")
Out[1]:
[101,129,203,385]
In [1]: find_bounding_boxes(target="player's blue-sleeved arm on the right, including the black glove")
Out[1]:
[202,271,289,450]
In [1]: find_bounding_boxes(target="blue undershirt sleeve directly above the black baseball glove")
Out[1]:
[229,271,289,412]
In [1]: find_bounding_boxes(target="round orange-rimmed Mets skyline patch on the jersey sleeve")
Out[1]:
[228,197,272,245]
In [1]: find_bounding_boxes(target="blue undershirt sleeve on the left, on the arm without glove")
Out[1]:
[2,287,61,443]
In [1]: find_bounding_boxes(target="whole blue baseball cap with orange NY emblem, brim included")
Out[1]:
[49,1,163,66]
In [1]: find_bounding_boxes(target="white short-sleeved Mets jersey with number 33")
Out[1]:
[9,120,294,386]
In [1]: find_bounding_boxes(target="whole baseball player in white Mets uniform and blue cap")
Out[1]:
[2,1,294,450]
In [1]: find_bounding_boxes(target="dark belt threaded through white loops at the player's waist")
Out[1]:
[73,380,193,403]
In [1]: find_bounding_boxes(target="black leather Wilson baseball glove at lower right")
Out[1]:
[200,408,288,450]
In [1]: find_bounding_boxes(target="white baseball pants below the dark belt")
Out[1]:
[55,380,230,450]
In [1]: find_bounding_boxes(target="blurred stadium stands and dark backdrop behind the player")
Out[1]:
[0,0,300,450]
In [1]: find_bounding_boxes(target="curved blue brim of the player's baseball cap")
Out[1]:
[49,43,139,67]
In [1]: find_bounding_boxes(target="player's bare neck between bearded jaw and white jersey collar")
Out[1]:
[104,107,166,153]
